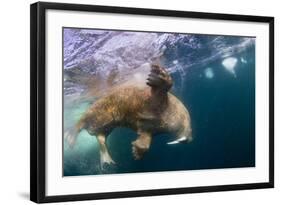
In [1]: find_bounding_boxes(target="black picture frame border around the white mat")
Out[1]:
[30,2,274,203]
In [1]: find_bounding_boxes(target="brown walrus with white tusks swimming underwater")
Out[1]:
[65,64,192,165]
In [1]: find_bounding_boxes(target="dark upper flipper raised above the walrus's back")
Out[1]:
[146,64,173,92]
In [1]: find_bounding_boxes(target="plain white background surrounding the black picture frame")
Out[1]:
[0,0,276,205]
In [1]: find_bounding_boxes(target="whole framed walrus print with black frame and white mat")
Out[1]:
[30,2,274,203]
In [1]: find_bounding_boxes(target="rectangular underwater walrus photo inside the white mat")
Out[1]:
[62,27,255,176]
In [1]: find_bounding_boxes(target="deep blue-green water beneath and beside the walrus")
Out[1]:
[64,32,255,176]
